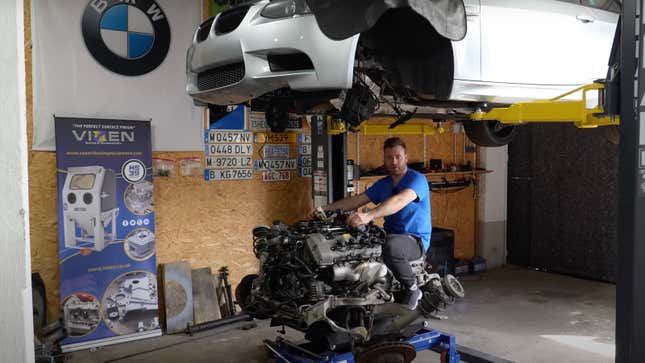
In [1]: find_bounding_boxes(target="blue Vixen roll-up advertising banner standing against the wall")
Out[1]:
[55,117,161,351]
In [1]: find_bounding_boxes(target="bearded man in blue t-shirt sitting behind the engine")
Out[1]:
[310,137,432,310]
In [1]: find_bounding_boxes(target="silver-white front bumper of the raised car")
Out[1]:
[186,1,359,105]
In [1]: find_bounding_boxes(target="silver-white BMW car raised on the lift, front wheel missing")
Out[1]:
[186,0,620,146]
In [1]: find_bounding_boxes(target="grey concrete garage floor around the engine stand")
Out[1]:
[67,266,615,363]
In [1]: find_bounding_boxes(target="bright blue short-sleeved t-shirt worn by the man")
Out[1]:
[365,168,432,251]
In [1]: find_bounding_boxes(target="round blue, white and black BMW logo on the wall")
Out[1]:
[82,0,170,76]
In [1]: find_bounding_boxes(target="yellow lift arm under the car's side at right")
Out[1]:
[470,83,620,128]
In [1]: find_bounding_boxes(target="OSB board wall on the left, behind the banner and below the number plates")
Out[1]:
[25,0,311,319]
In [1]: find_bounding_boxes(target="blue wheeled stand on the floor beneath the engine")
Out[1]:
[264,329,460,363]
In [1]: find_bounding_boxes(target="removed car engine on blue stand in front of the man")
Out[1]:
[236,211,464,350]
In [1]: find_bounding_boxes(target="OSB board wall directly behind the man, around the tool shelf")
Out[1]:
[347,118,477,258]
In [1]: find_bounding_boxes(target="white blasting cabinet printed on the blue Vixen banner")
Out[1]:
[62,166,119,251]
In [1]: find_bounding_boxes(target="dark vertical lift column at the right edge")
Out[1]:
[616,0,645,363]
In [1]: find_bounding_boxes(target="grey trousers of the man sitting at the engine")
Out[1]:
[383,234,423,288]
